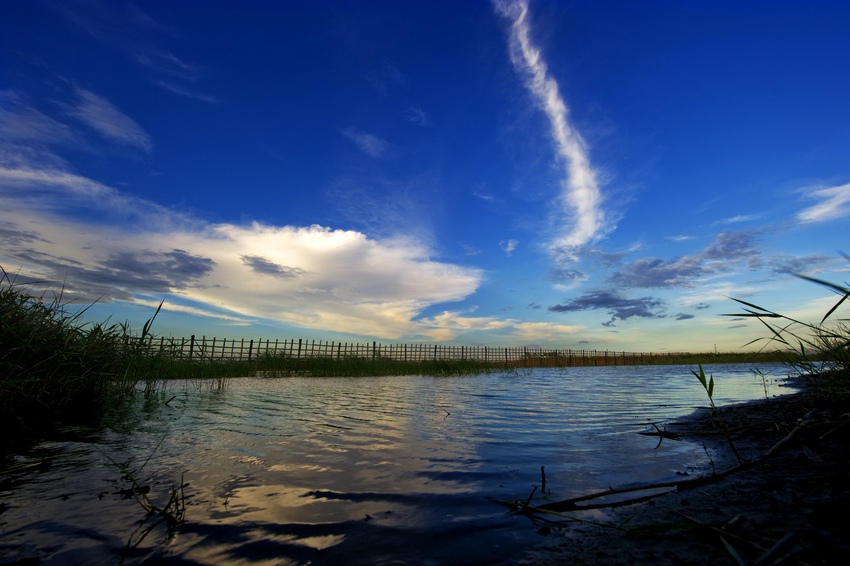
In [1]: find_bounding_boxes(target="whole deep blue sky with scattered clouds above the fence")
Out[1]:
[0,0,850,352]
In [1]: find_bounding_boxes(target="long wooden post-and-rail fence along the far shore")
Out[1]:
[132,335,681,367]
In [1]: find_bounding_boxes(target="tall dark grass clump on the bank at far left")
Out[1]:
[0,268,164,428]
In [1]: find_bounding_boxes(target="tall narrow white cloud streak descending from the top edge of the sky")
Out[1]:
[494,0,605,256]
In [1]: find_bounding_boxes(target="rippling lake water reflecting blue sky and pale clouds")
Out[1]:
[0,364,790,565]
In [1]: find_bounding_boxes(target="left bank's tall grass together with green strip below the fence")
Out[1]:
[0,267,508,428]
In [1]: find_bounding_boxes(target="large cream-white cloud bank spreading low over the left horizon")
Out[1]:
[0,168,484,339]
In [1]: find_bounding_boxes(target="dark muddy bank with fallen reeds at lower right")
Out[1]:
[519,378,850,565]
